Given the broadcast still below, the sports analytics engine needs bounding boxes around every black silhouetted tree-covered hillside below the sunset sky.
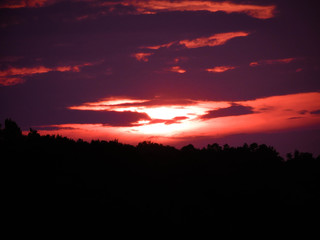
[0,119,320,235]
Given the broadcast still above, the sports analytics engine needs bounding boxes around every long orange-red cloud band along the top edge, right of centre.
[100,0,276,19]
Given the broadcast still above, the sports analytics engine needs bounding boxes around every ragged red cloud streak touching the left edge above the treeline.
[0,63,92,86]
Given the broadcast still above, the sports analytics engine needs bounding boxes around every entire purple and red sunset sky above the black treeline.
[0,0,320,155]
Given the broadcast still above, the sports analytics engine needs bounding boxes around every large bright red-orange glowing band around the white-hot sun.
[40,92,320,144]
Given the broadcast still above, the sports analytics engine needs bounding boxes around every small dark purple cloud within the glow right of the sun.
[201,104,255,119]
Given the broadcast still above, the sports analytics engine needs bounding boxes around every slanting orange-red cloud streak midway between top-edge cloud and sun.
[142,32,250,49]
